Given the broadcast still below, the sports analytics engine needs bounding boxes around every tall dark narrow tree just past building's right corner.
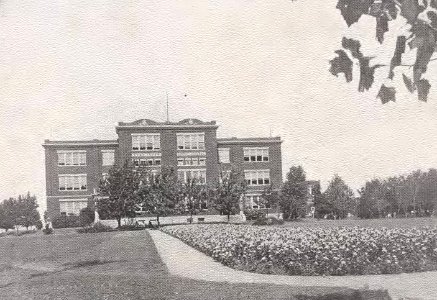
[279,166,307,220]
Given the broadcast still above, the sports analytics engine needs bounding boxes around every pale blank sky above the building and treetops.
[0,0,437,211]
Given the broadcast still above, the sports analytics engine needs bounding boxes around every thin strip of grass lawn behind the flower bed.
[279,217,437,228]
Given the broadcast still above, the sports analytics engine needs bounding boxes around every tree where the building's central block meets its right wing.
[213,169,246,222]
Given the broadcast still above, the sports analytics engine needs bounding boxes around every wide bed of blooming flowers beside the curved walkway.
[162,224,437,275]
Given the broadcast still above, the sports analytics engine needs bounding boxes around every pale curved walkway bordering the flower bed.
[149,230,437,300]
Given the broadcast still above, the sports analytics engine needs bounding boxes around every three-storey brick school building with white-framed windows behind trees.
[43,119,282,219]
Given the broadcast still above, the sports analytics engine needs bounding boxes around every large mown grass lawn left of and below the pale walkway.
[0,230,386,300]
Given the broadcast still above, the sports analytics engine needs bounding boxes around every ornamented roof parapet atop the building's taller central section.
[116,119,218,129]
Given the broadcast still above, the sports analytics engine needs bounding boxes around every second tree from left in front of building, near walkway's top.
[136,168,183,226]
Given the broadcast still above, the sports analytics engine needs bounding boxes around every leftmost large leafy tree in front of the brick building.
[97,162,147,227]
